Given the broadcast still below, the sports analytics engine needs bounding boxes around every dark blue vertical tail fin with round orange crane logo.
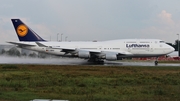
[11,19,45,41]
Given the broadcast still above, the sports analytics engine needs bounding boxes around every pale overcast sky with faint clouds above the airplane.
[0,0,180,44]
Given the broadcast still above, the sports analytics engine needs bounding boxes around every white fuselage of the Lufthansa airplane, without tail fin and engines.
[17,39,174,57]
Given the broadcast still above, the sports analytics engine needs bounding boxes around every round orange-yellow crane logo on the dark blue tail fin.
[17,24,28,37]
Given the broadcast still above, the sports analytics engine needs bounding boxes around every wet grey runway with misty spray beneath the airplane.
[0,56,180,66]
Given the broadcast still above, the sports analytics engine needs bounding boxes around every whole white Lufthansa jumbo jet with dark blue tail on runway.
[8,19,174,65]
